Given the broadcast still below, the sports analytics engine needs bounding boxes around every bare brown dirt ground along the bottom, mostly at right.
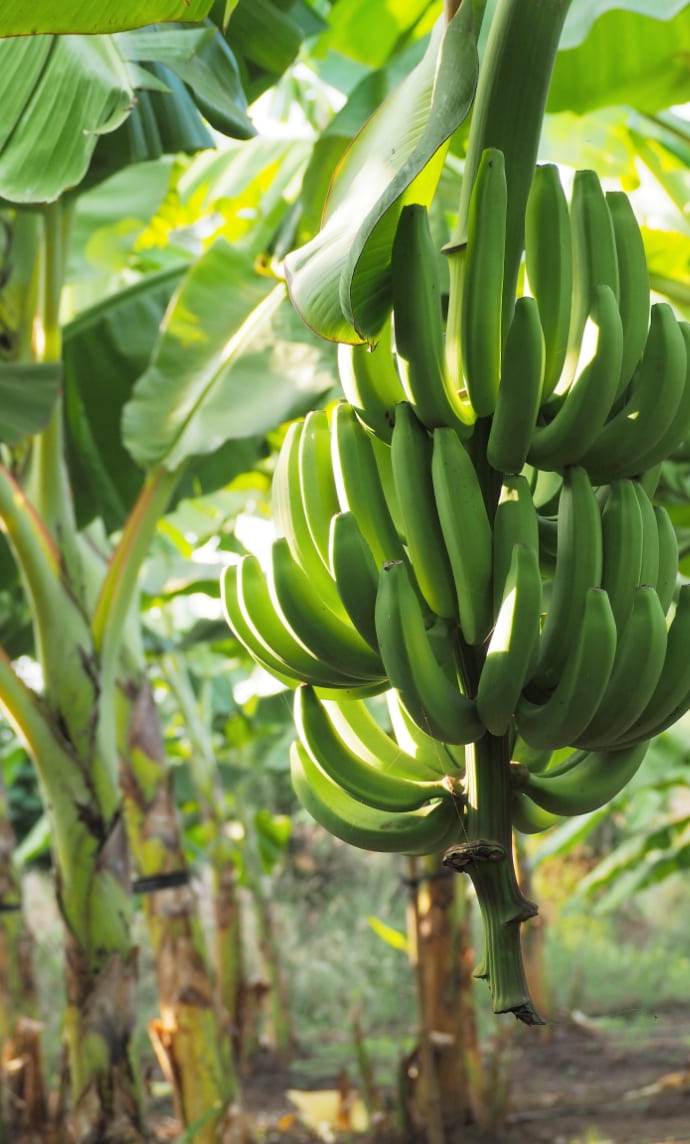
[230,1009,690,1144]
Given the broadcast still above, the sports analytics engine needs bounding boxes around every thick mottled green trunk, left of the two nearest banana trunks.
[0,636,144,1144]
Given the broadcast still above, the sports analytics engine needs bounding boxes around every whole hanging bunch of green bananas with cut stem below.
[222,143,690,1022]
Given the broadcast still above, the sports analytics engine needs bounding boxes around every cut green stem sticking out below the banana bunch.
[443,734,544,1025]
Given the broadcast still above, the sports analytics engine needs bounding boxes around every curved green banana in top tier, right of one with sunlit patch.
[580,302,688,484]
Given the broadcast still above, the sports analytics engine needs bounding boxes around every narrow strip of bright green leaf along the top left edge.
[0,0,213,35]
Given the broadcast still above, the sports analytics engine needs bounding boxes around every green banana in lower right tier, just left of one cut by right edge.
[573,585,666,749]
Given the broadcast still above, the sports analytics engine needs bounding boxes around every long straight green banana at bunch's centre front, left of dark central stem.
[431,429,493,645]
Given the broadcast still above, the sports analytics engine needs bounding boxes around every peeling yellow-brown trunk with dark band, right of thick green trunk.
[119,678,238,1144]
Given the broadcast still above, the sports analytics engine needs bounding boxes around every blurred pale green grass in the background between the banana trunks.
[16,827,690,1086]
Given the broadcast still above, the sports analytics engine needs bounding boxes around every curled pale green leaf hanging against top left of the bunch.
[285,3,477,342]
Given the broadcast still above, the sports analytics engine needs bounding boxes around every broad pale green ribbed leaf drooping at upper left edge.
[0,35,135,202]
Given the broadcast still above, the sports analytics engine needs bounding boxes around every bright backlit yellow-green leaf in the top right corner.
[547,0,690,114]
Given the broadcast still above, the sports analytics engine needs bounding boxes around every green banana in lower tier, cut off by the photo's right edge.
[613,583,690,745]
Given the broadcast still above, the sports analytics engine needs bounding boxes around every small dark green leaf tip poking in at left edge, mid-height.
[0,362,62,445]
